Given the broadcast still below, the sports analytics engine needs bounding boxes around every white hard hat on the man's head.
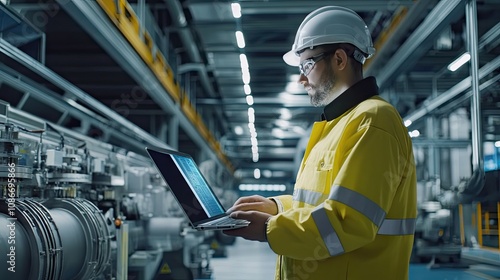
[283,6,375,66]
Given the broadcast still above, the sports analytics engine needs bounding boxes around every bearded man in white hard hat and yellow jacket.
[225,6,417,280]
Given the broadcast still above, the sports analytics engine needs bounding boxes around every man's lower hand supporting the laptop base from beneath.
[223,211,272,241]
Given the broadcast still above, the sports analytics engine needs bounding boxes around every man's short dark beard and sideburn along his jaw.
[309,64,337,107]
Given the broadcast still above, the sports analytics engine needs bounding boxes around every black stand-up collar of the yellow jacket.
[321,77,378,121]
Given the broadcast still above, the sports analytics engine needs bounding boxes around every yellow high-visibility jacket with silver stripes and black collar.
[266,77,417,280]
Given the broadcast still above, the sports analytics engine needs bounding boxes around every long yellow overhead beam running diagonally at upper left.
[97,0,234,172]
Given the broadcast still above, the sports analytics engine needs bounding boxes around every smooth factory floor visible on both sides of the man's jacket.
[211,238,500,280]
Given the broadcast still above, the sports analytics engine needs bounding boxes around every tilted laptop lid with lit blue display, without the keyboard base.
[147,149,225,223]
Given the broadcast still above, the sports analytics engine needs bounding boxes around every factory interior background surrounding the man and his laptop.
[0,0,500,280]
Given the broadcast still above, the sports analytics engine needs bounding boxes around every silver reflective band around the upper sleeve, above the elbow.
[328,186,386,227]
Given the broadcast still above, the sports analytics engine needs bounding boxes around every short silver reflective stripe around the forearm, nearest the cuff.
[311,203,344,256]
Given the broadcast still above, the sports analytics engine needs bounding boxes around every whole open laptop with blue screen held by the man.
[146,147,250,230]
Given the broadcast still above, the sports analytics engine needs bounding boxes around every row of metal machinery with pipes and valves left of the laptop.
[0,103,225,280]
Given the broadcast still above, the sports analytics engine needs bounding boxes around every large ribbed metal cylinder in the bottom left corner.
[0,198,111,280]
